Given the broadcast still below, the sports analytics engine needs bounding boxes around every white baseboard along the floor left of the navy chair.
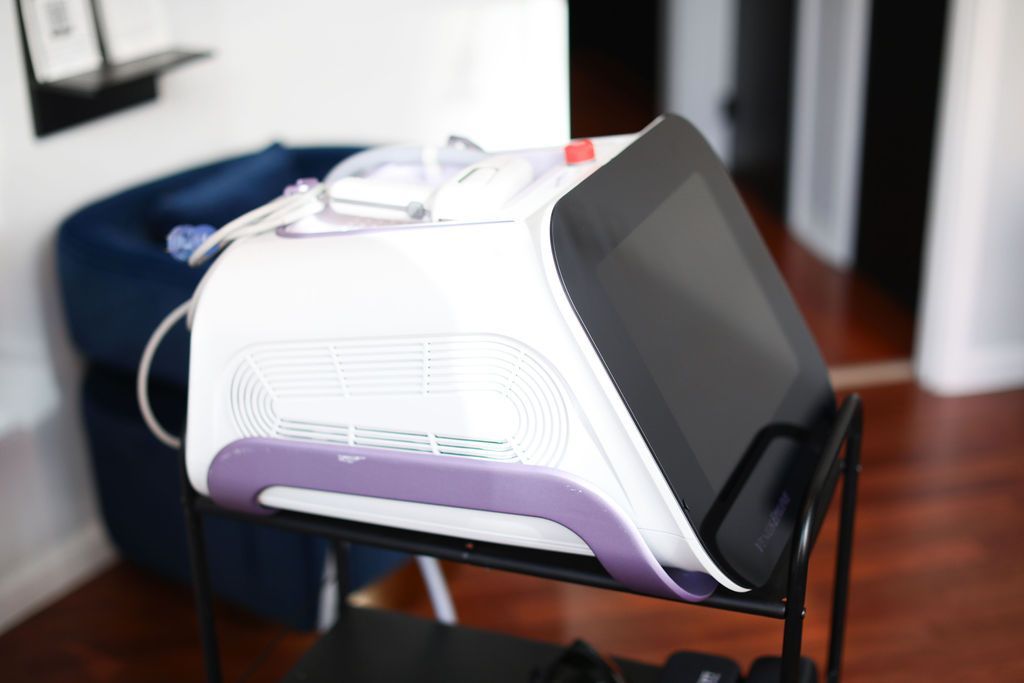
[0,519,117,633]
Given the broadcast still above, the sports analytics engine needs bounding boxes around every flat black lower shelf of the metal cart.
[284,607,658,683]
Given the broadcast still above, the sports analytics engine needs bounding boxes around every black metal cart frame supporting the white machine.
[181,394,863,683]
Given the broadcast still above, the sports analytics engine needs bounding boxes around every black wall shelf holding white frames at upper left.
[14,0,212,137]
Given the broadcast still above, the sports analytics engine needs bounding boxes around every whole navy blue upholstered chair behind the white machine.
[57,145,406,628]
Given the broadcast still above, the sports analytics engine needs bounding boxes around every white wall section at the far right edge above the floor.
[915,0,1024,394]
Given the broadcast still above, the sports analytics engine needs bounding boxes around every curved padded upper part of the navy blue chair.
[57,143,358,386]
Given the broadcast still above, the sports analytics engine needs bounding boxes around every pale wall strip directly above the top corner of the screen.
[662,0,739,166]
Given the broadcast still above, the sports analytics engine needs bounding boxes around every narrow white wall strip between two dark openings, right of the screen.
[786,0,871,268]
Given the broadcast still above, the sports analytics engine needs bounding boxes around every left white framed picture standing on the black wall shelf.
[20,0,103,83]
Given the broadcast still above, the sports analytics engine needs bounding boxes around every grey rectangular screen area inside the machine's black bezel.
[597,175,797,490]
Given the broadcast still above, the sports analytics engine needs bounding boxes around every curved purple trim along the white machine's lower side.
[208,438,716,602]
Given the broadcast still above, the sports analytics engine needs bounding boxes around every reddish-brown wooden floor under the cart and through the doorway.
[0,194,1024,682]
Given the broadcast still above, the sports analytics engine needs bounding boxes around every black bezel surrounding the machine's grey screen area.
[551,115,835,585]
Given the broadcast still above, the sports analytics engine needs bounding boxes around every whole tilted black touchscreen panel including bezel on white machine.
[551,116,835,585]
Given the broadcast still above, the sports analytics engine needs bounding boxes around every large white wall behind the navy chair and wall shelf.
[0,0,568,630]
